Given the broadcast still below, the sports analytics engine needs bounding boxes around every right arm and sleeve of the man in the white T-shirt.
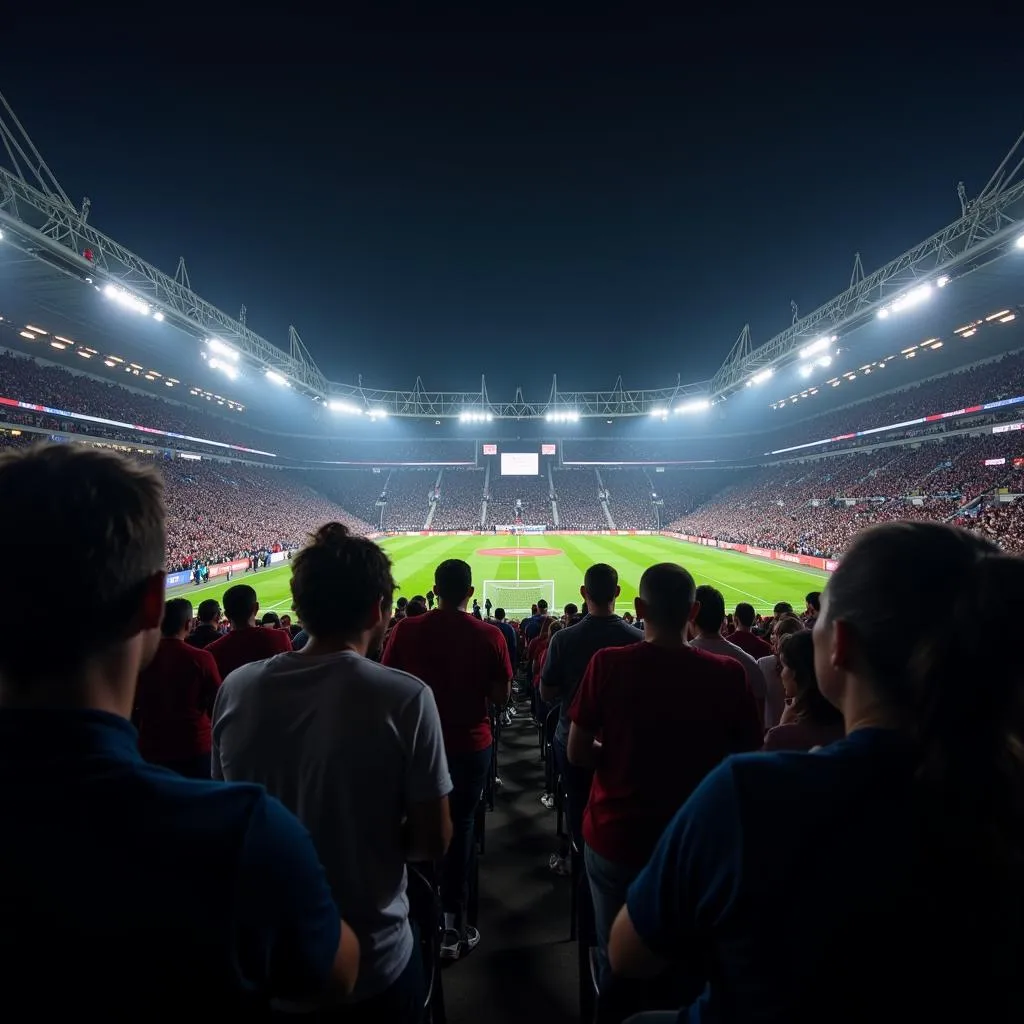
[399,684,452,862]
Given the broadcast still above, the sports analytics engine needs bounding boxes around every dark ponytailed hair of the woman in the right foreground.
[824,522,1024,868]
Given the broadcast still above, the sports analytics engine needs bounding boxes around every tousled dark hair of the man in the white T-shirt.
[292,522,395,637]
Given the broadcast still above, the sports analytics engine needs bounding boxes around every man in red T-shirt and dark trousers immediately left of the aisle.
[382,558,512,959]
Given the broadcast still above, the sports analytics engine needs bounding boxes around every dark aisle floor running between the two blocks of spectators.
[443,716,578,1024]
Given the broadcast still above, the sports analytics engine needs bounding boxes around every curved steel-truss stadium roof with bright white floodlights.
[0,89,1024,423]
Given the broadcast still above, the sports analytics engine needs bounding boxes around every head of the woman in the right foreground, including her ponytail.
[814,522,1024,831]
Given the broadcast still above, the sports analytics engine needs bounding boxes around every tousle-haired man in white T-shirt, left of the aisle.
[214,523,452,1024]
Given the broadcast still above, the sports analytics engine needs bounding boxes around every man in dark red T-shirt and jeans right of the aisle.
[568,562,763,977]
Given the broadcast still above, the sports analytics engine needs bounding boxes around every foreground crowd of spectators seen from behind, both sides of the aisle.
[0,444,1024,1024]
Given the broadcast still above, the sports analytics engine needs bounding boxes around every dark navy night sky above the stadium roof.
[0,17,1024,396]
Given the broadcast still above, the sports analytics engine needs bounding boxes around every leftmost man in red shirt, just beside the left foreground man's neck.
[133,597,220,778]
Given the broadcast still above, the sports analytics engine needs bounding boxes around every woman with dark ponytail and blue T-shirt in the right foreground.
[609,522,1024,1024]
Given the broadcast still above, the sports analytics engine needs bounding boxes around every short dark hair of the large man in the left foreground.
[0,443,166,683]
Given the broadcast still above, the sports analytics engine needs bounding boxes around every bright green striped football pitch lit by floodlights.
[167,534,827,614]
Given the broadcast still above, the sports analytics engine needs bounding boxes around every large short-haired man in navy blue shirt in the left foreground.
[0,444,358,1021]
